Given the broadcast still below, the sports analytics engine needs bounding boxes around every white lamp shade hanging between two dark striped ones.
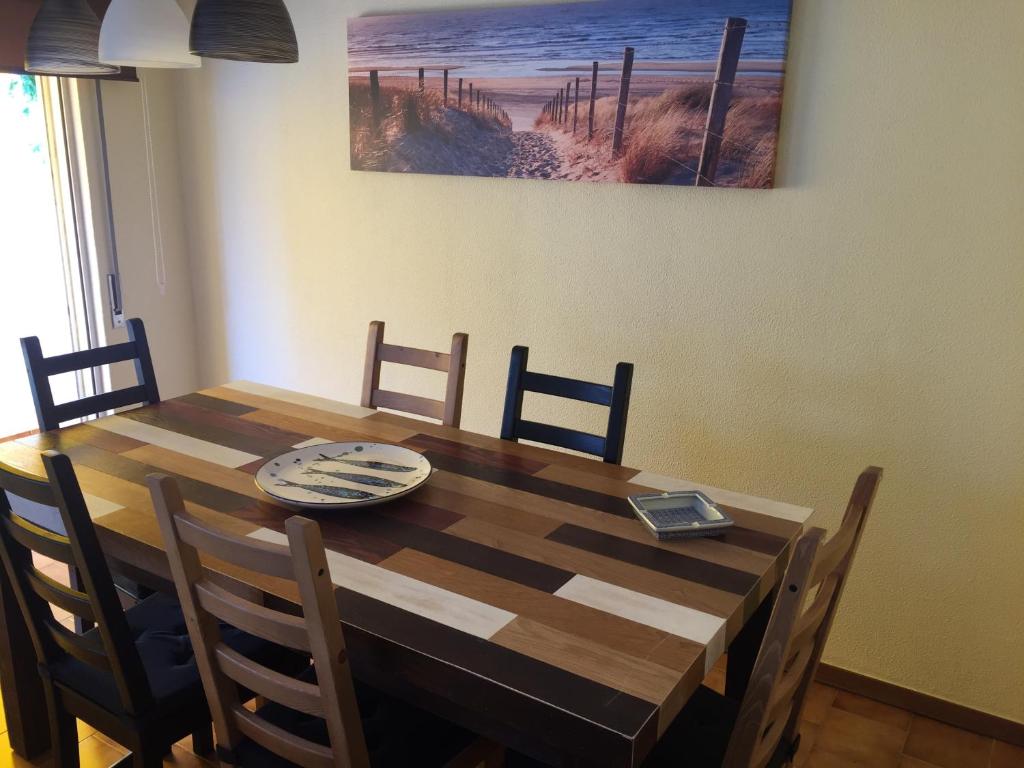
[99,0,203,69]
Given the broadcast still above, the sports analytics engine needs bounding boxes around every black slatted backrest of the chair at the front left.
[0,451,153,715]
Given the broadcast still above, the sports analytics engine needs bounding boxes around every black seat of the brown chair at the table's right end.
[507,685,790,768]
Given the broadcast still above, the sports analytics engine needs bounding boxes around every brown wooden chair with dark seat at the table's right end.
[645,467,882,768]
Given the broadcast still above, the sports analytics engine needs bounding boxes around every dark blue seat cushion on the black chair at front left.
[50,594,301,717]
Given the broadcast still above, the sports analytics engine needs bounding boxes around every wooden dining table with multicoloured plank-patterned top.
[0,382,811,768]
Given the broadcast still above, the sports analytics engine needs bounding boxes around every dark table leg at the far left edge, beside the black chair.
[0,568,50,760]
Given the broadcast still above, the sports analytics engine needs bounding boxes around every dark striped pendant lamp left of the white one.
[25,0,121,75]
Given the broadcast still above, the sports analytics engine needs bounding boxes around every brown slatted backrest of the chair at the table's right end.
[724,467,882,768]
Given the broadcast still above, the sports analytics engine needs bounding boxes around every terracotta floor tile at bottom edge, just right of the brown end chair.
[809,707,906,768]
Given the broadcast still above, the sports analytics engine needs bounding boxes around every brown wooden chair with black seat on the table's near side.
[148,475,500,768]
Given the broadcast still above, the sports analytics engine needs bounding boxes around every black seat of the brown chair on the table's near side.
[234,668,476,768]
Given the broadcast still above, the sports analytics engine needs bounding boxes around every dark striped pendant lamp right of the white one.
[189,0,299,63]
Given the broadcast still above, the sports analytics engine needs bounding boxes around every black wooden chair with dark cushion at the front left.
[0,452,225,768]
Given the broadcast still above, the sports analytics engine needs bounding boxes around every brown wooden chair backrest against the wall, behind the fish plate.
[361,321,469,427]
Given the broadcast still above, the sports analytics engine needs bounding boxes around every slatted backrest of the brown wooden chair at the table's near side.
[148,475,369,768]
